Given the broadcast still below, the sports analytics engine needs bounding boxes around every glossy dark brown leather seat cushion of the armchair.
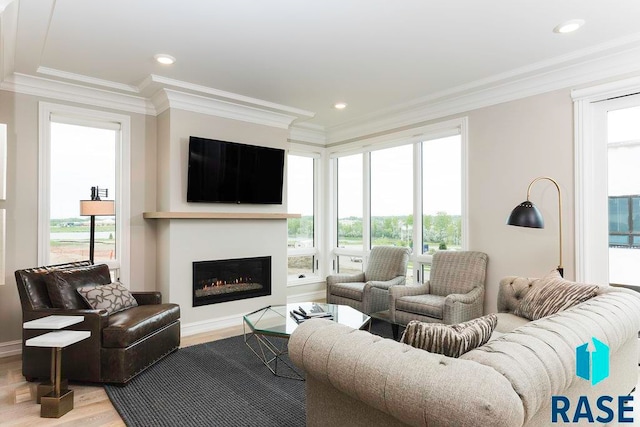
[102,304,180,348]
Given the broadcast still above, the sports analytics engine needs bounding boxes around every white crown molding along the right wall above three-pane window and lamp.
[327,34,640,145]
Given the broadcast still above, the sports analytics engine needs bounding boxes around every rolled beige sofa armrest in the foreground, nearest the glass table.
[289,319,524,427]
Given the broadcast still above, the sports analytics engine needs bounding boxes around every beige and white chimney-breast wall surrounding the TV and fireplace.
[156,109,289,333]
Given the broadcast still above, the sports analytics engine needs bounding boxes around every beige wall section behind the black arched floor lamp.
[467,90,575,312]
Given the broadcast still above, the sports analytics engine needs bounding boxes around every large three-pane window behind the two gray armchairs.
[332,119,466,284]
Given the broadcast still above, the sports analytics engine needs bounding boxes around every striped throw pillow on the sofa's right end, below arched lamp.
[513,270,598,320]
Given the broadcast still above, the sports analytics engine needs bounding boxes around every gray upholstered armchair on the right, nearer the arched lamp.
[389,251,489,325]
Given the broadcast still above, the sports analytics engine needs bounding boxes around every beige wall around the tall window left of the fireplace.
[0,90,156,344]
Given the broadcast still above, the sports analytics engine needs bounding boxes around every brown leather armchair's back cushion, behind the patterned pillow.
[45,264,111,310]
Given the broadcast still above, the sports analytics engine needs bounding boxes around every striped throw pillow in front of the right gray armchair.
[400,314,498,357]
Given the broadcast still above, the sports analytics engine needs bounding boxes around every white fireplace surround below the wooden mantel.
[157,219,287,336]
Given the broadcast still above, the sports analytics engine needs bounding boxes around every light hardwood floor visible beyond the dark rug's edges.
[0,326,242,427]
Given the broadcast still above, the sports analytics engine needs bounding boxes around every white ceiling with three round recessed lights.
[0,0,640,129]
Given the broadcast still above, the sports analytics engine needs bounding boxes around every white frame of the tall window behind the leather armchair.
[38,102,131,286]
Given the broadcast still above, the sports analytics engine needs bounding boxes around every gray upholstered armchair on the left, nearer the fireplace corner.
[327,246,409,314]
